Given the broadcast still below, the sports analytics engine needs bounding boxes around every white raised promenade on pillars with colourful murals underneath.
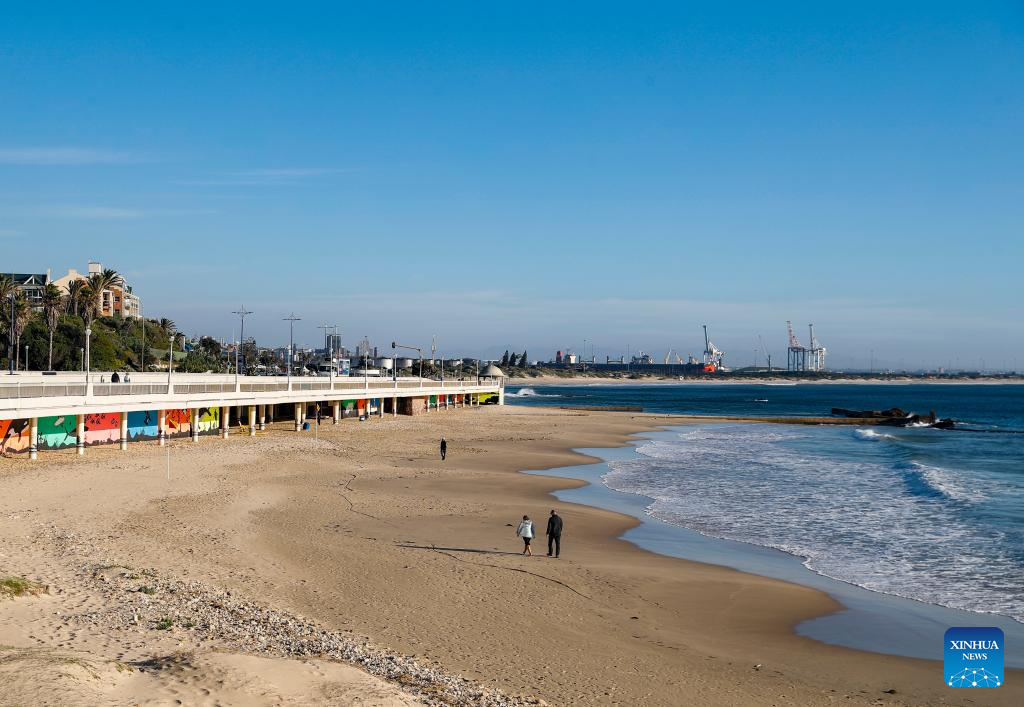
[0,372,504,459]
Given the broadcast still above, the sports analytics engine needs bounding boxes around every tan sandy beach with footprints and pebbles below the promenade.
[0,405,1024,706]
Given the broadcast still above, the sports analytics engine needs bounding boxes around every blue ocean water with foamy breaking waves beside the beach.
[507,384,1024,622]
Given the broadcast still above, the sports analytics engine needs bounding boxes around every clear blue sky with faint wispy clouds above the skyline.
[0,2,1024,368]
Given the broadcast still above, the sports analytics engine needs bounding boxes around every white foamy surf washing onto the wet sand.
[604,424,1024,621]
